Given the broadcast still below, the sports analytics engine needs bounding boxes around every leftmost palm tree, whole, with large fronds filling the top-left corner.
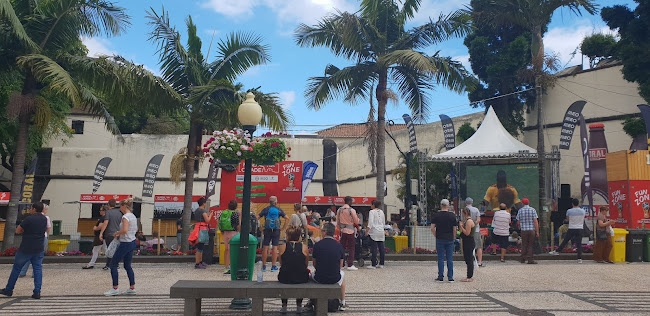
[0,0,173,248]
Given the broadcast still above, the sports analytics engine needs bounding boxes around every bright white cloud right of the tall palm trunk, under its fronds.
[544,21,614,67]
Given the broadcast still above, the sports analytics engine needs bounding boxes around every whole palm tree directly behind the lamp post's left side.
[147,9,292,251]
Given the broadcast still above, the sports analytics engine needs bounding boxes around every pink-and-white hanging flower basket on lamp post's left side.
[203,129,253,165]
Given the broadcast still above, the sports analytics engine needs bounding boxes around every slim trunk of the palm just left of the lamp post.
[181,120,201,252]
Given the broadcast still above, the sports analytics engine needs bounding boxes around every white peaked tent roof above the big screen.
[429,107,537,161]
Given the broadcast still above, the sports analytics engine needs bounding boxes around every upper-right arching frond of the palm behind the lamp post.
[209,33,271,81]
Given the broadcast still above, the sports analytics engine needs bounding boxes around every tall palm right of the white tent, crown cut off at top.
[478,0,598,243]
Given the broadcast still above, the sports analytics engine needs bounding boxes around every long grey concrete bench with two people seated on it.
[169,280,341,316]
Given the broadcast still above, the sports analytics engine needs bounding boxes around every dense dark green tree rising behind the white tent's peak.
[464,0,534,136]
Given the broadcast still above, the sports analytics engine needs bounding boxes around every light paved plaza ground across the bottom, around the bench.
[0,260,650,316]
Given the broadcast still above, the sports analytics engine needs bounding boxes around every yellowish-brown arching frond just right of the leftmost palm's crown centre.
[16,54,80,105]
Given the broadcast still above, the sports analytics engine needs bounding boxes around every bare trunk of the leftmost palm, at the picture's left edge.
[2,113,29,250]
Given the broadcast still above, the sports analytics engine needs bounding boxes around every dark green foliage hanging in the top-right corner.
[601,0,650,103]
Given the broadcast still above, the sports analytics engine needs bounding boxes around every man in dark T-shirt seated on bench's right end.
[311,223,347,311]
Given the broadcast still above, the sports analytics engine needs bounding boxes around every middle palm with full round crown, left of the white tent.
[295,0,473,206]
